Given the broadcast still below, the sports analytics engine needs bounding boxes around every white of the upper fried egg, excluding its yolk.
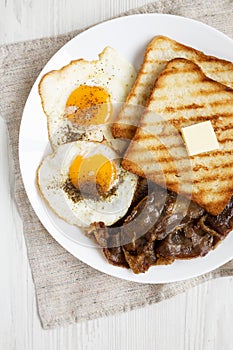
[39,47,136,149]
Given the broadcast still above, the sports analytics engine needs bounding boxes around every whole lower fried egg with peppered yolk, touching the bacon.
[37,141,138,227]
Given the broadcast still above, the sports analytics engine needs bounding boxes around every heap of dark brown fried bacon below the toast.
[89,186,233,273]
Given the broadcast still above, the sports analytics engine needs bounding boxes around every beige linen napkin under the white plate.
[0,0,233,328]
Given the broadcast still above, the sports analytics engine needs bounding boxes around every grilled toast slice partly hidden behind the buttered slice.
[112,36,233,139]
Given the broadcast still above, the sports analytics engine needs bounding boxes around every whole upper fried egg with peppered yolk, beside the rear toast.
[39,47,136,149]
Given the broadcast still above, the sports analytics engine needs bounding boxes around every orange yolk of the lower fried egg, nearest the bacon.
[69,154,117,195]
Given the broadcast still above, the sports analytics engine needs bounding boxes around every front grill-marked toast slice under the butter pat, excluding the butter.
[122,58,233,215]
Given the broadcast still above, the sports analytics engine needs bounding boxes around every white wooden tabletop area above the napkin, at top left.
[0,0,150,44]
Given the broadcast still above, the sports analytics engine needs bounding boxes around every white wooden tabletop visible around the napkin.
[0,0,233,350]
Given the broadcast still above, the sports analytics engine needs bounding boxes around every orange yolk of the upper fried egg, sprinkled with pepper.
[66,85,112,126]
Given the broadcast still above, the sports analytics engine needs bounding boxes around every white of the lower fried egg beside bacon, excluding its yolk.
[37,141,138,227]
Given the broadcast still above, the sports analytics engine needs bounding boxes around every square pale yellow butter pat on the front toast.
[181,120,219,156]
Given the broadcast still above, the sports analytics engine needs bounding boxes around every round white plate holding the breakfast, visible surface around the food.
[19,14,233,283]
